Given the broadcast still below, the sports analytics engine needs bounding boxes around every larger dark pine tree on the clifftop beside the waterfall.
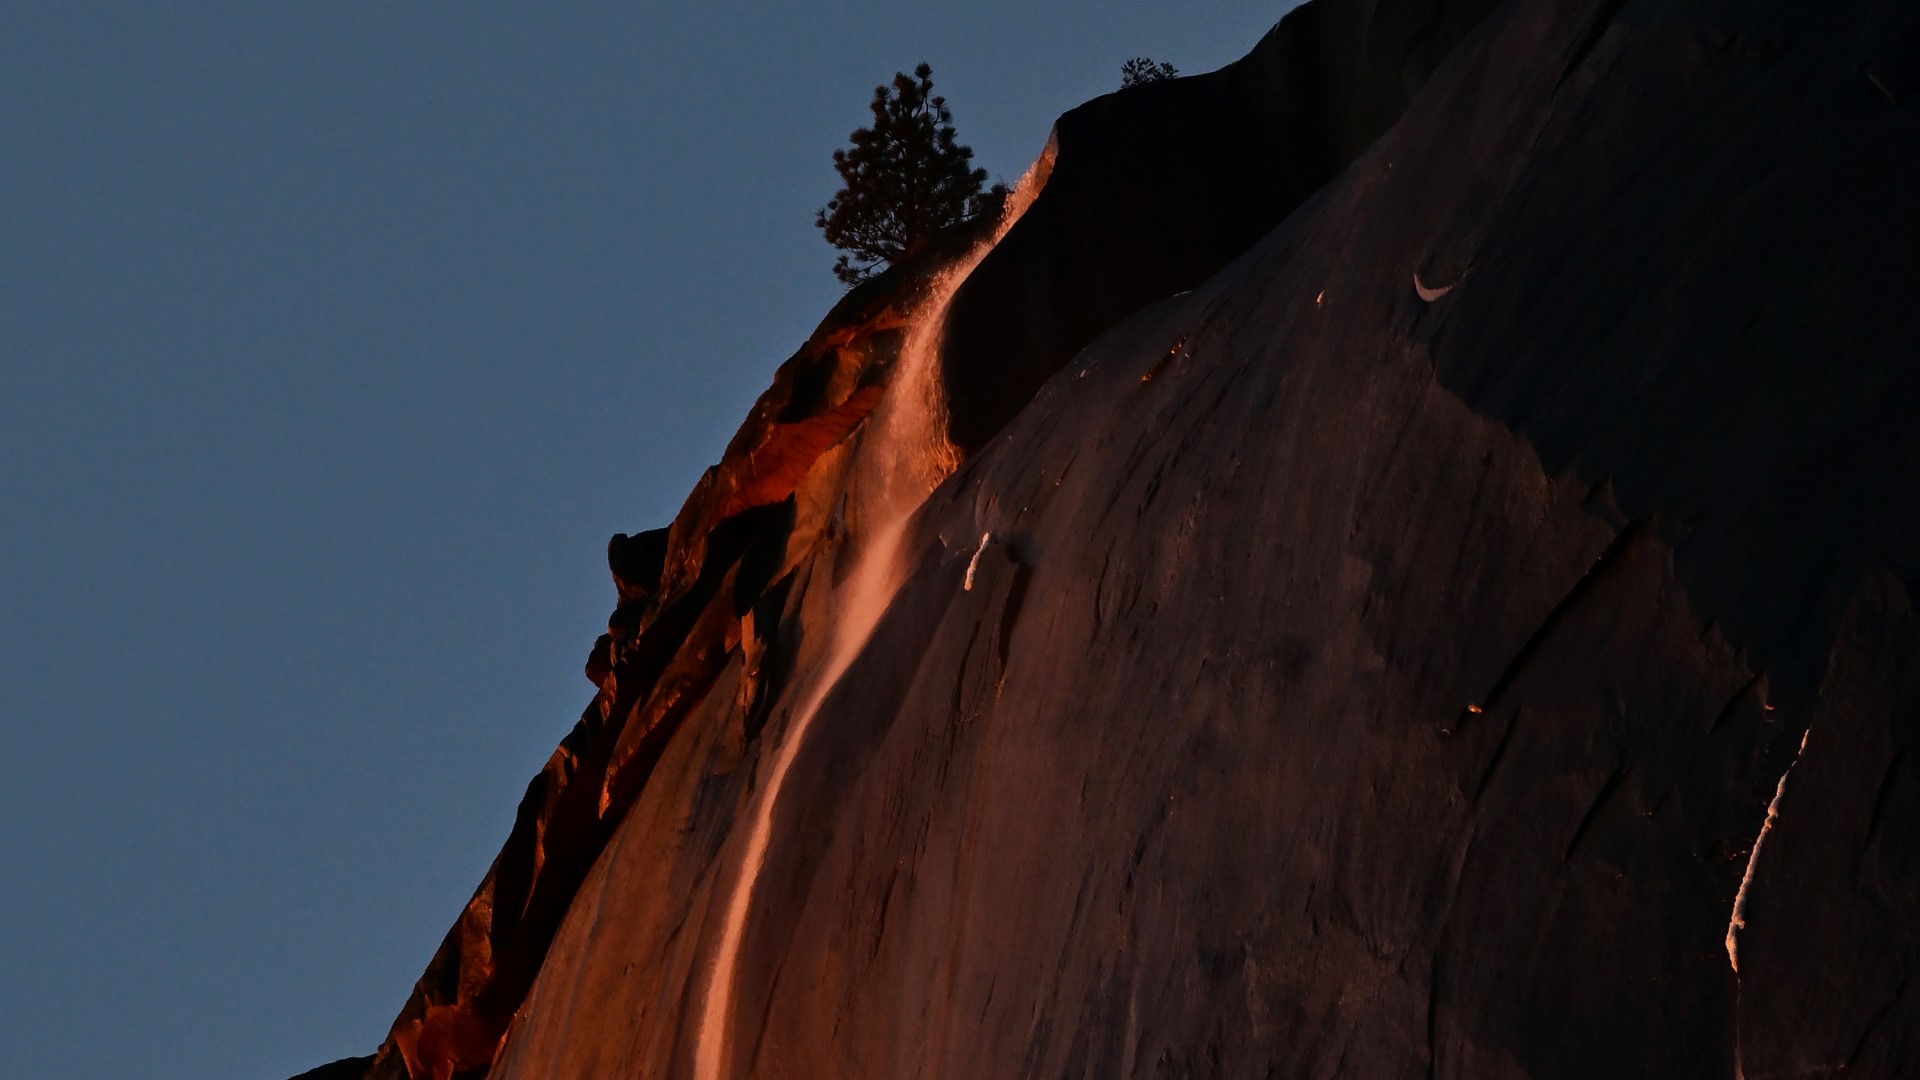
[814,63,1006,284]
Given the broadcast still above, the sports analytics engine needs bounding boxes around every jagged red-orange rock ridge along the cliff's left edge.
[341,178,985,1080]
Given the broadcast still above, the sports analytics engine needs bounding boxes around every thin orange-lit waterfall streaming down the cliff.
[693,142,1054,1080]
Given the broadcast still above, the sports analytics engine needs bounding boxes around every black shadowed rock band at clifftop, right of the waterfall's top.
[945,0,1494,454]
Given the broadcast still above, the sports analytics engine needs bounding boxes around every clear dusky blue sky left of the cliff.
[0,0,1290,1080]
